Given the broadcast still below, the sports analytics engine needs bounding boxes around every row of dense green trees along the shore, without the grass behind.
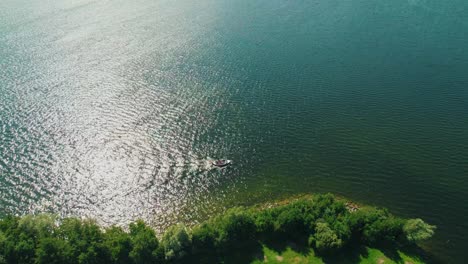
[0,194,435,264]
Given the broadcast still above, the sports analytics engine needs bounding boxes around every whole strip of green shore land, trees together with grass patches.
[0,194,437,264]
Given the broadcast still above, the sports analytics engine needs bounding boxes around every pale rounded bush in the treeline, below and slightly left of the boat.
[161,225,192,260]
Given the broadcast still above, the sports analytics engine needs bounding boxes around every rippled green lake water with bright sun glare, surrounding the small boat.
[0,0,468,263]
